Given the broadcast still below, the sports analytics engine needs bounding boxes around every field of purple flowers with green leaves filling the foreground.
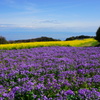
[0,47,100,100]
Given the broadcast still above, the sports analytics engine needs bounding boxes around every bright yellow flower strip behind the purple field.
[0,38,98,50]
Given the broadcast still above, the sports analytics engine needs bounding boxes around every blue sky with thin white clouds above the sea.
[0,0,100,36]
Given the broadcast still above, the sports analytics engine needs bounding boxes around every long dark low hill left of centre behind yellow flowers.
[9,37,61,43]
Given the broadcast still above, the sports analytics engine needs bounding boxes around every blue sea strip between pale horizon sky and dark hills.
[0,31,96,41]
